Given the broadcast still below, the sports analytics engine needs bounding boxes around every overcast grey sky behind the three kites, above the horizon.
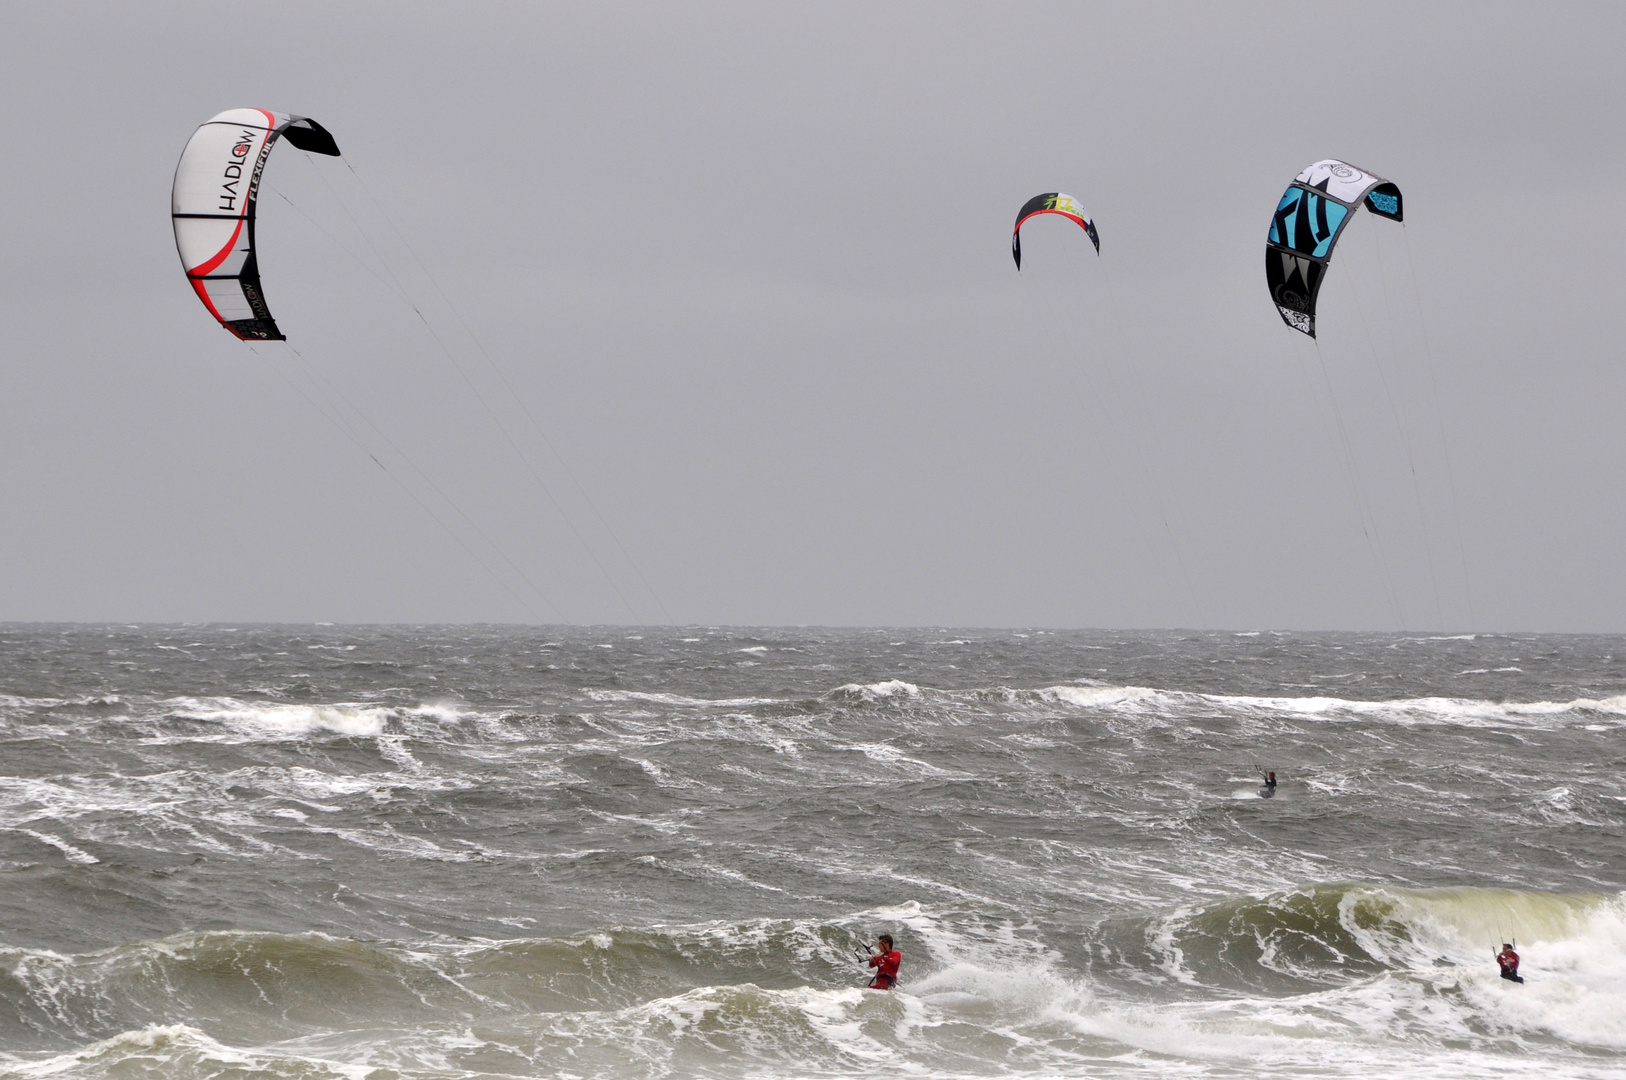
[0,2,1626,631]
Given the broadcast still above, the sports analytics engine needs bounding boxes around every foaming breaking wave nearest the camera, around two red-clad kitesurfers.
[0,885,1626,1077]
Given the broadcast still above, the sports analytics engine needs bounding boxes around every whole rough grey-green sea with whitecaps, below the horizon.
[0,625,1626,1080]
